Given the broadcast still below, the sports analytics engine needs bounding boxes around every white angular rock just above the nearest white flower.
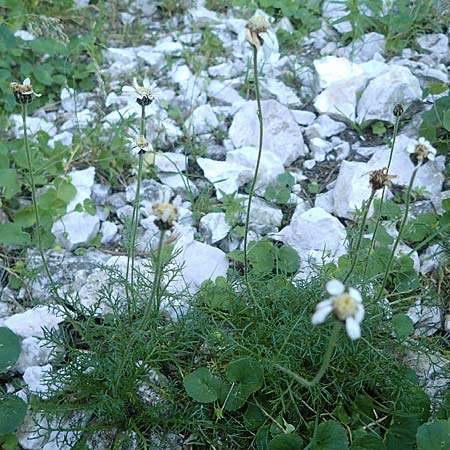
[275,207,346,261]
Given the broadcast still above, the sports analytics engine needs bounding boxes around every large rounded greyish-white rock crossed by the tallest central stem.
[229,100,306,165]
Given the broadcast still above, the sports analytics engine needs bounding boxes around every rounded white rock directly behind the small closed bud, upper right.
[356,66,422,124]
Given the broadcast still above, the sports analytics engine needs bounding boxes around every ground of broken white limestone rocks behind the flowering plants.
[0,1,450,450]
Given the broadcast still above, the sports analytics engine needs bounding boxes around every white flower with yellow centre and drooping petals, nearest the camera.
[312,280,364,339]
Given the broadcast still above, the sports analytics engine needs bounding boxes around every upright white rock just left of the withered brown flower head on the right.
[333,161,373,219]
